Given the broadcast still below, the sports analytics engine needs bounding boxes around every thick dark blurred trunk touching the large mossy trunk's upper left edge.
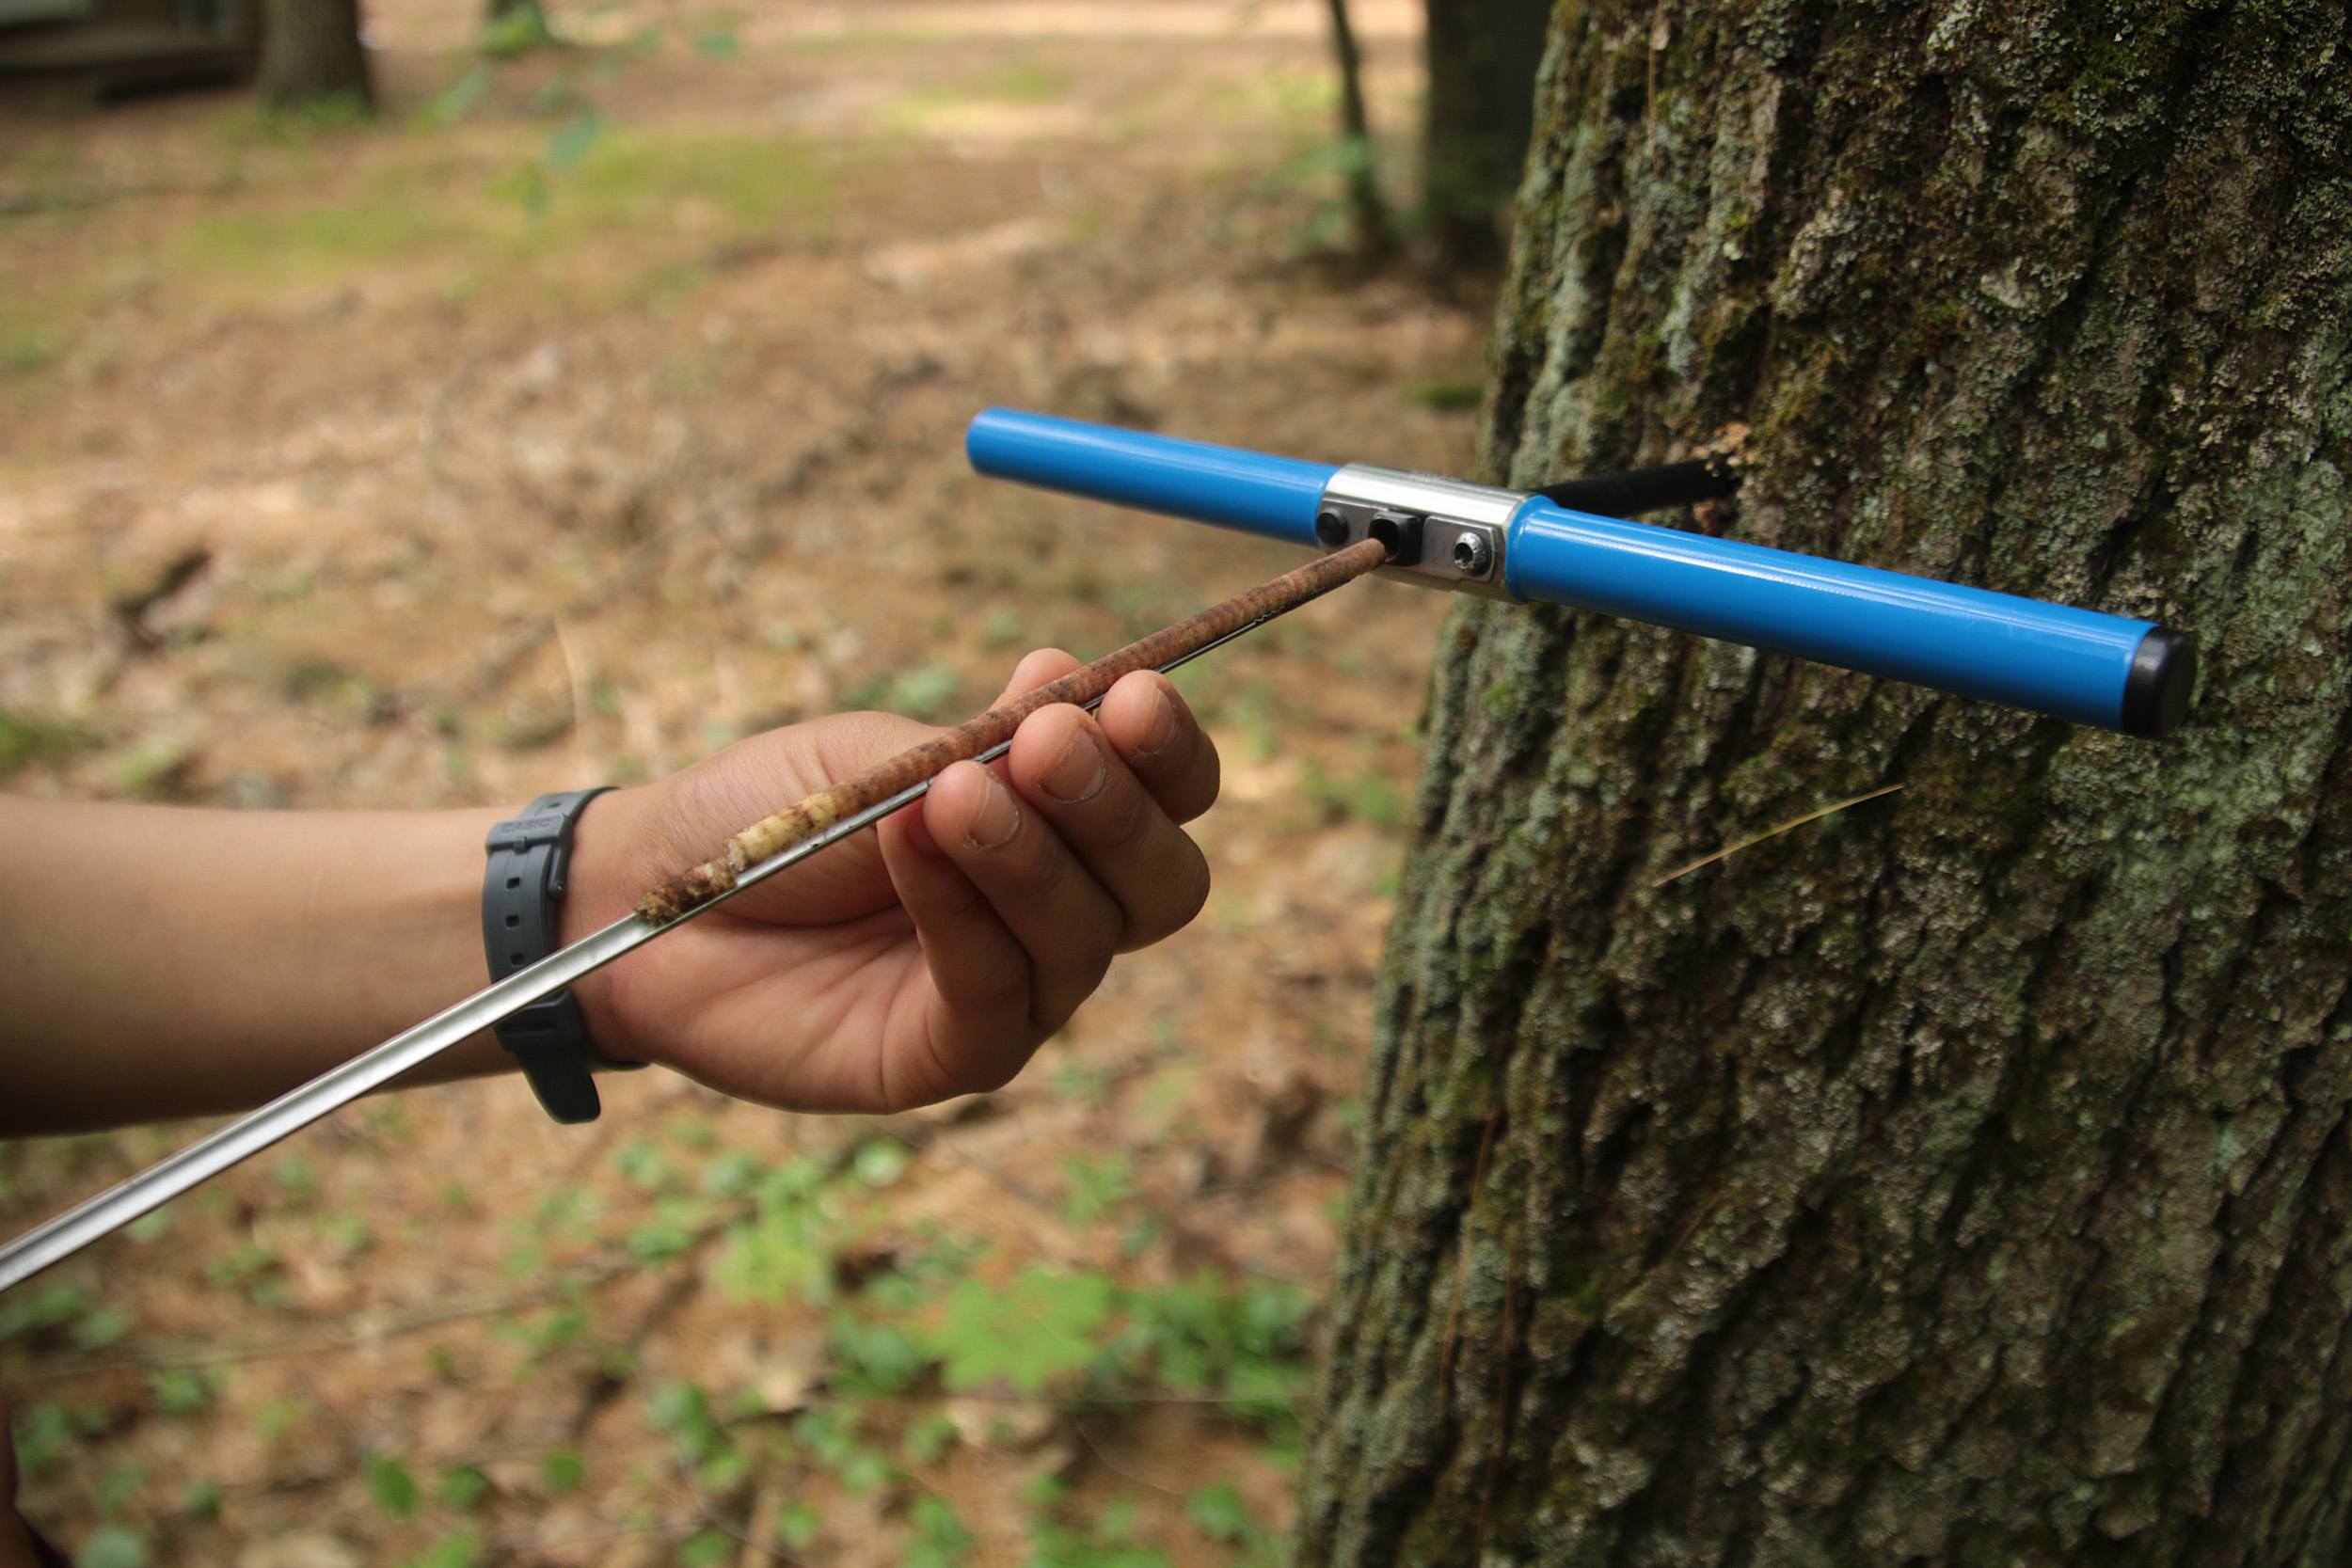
[1421,0,1552,268]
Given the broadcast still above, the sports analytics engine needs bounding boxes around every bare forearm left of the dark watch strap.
[0,797,511,1133]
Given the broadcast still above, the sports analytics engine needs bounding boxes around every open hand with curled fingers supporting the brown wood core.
[563,649,1218,1112]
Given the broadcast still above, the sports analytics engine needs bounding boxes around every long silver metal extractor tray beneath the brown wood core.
[0,611,1279,1291]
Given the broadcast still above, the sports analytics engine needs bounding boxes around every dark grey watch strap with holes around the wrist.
[483,785,644,1121]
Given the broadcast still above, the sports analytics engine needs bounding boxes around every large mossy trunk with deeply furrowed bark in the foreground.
[1298,0,2352,1568]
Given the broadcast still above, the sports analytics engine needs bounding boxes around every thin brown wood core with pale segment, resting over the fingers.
[638,538,1388,927]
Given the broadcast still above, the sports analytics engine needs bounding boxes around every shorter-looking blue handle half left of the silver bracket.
[964,409,1339,547]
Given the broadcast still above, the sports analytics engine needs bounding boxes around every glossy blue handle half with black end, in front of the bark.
[1503,499,2154,734]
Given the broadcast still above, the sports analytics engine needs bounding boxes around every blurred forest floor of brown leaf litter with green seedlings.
[0,0,1485,1568]
